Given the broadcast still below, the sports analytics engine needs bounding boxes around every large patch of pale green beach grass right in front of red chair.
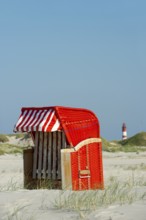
[54,175,146,216]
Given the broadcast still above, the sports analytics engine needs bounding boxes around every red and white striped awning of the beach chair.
[14,108,61,132]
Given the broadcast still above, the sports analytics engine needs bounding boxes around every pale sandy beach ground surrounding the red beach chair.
[0,152,146,220]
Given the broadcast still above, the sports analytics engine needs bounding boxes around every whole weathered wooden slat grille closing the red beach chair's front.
[33,131,67,180]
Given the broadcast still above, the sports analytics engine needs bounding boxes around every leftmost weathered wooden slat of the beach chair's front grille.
[33,132,39,179]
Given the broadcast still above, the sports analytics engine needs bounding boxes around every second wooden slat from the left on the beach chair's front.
[38,132,43,179]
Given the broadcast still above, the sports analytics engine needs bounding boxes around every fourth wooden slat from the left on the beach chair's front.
[48,132,52,179]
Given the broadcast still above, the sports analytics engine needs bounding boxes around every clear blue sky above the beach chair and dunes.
[0,0,146,140]
